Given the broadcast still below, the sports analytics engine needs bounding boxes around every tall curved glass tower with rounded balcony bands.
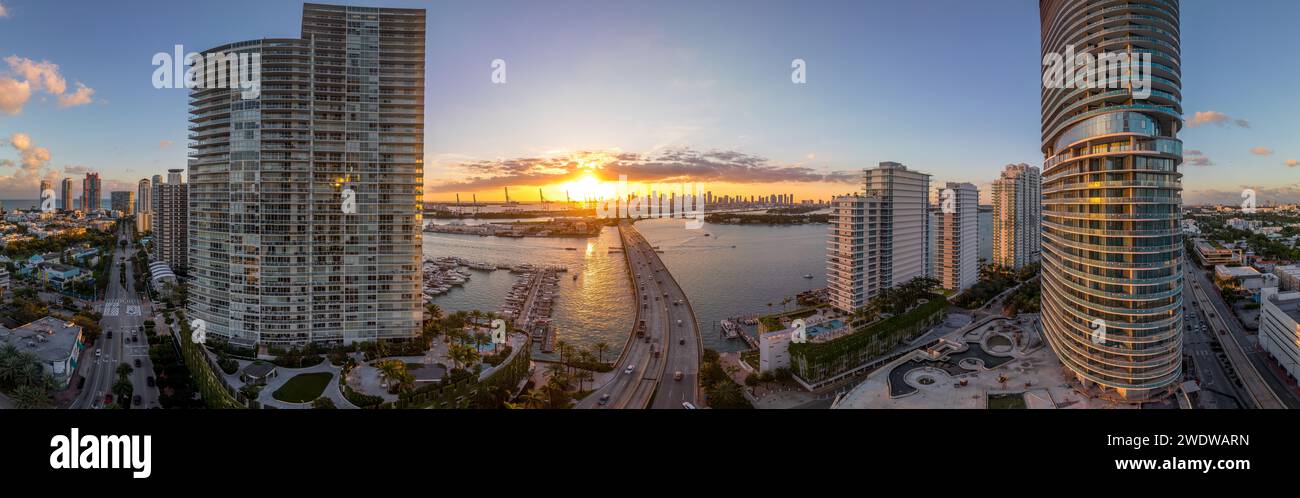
[1039,0,1183,402]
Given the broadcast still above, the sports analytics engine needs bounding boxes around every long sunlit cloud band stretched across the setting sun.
[426,148,861,194]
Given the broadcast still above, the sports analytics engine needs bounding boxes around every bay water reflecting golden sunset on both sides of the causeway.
[424,220,827,360]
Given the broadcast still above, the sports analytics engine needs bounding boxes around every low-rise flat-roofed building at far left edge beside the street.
[0,316,86,387]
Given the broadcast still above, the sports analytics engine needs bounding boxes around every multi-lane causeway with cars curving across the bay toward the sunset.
[577,222,702,408]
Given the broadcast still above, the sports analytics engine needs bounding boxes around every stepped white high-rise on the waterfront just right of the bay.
[827,163,930,311]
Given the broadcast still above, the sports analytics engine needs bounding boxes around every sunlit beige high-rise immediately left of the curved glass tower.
[991,164,1043,269]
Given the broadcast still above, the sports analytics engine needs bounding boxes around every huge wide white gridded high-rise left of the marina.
[188,4,425,346]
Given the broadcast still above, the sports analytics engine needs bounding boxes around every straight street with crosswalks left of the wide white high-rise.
[70,224,159,408]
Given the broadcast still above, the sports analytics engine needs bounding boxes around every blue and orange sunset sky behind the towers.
[0,0,1300,204]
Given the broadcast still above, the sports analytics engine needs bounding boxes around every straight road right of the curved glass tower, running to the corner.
[1183,256,1300,408]
